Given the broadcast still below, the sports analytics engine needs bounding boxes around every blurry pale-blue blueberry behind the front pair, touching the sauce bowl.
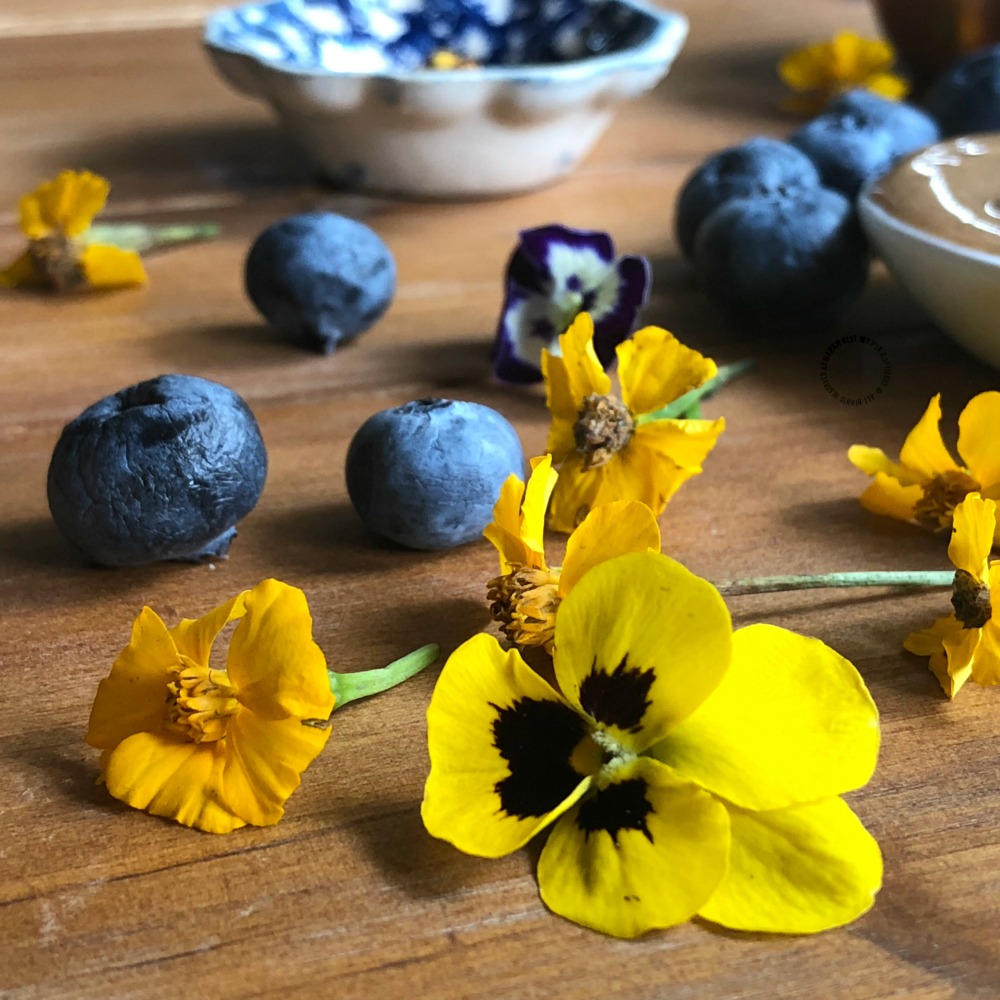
[788,90,939,198]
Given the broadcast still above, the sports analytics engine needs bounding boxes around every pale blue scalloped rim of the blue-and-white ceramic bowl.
[202,0,689,86]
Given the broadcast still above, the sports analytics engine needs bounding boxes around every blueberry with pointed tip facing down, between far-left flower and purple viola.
[245,212,396,354]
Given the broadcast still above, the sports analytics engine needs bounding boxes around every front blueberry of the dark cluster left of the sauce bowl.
[695,187,868,332]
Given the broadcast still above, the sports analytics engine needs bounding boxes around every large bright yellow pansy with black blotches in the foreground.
[422,553,882,937]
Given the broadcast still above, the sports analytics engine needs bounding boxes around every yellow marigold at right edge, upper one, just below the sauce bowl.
[847,392,1000,542]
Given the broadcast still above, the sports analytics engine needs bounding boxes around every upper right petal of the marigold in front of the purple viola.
[615,326,718,415]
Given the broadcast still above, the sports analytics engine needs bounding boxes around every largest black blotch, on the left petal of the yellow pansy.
[493,698,587,816]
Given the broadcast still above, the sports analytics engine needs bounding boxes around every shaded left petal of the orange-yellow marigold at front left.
[87,608,181,752]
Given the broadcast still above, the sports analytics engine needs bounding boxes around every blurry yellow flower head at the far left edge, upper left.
[0,170,146,292]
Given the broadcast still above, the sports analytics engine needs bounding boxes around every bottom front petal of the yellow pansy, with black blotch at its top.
[538,758,729,938]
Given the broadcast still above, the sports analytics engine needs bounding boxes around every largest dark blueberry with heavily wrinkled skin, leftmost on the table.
[48,375,267,566]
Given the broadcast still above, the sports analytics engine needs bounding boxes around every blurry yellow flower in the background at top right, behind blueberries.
[778,31,910,115]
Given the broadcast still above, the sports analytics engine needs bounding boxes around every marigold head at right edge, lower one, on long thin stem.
[903,493,1000,698]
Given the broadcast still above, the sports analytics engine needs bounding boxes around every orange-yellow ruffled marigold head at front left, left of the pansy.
[87,580,334,833]
